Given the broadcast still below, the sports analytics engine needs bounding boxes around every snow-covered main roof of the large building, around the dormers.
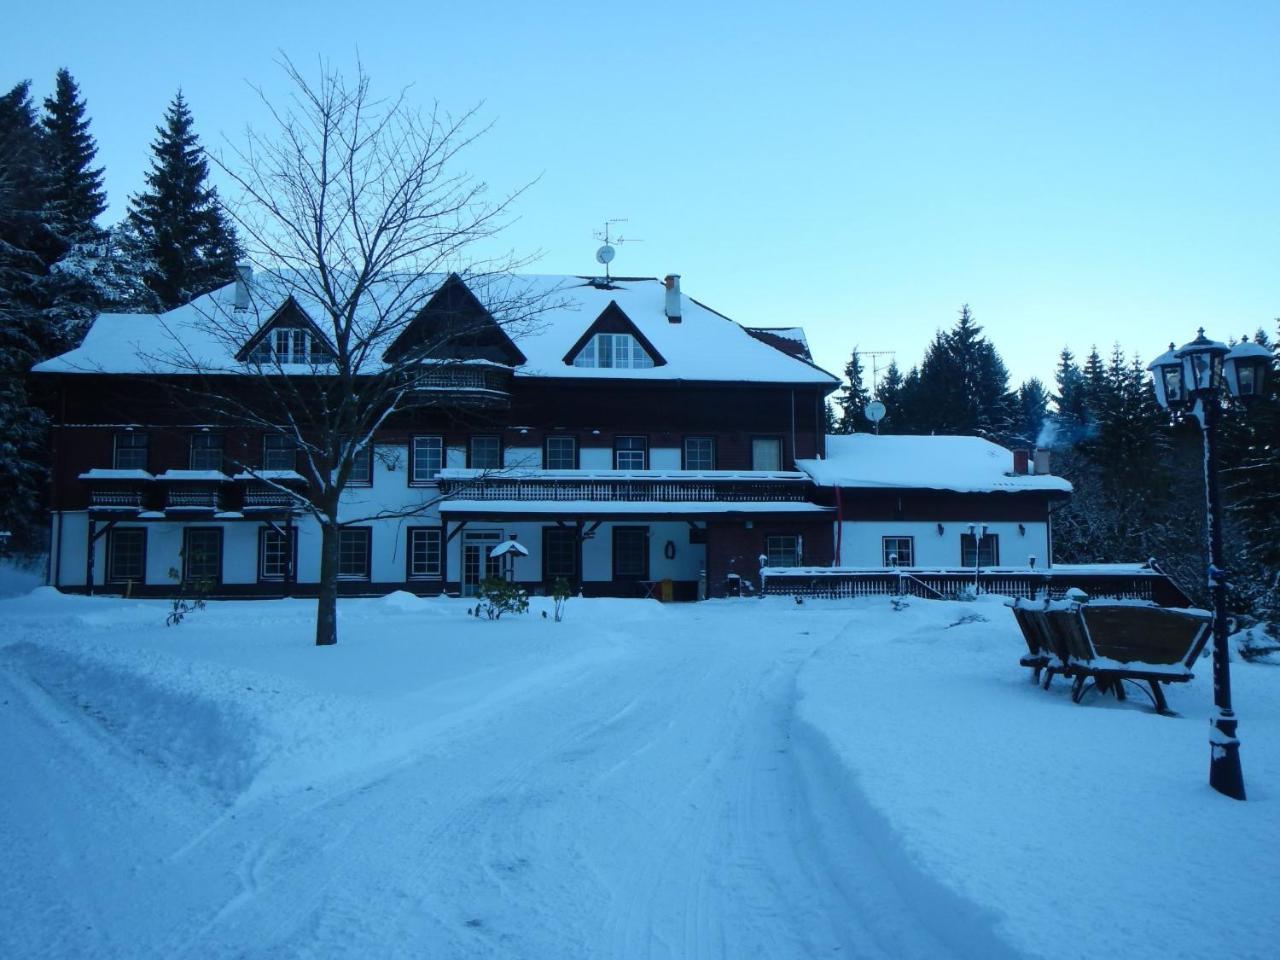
[36,274,838,387]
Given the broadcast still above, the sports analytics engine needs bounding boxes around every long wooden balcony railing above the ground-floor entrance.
[440,476,808,503]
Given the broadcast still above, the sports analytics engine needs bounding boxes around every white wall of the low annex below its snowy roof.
[840,518,1048,567]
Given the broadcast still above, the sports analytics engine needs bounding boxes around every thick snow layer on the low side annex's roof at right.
[796,434,1071,493]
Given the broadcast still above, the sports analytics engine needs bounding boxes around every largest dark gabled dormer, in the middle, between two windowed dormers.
[384,274,525,366]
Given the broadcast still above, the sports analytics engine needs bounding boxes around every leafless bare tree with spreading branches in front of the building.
[154,59,547,645]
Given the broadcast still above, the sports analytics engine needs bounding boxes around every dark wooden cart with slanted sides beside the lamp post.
[1012,594,1212,713]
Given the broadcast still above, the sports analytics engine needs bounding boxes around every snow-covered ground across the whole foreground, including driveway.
[0,589,1280,960]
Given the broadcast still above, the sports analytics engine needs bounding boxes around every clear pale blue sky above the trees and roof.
[0,0,1280,383]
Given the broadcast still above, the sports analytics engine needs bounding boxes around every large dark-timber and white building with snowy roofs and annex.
[36,275,1069,599]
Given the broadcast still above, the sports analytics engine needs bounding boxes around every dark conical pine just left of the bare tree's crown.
[129,91,239,310]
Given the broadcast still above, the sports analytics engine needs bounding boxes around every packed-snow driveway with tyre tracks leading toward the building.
[0,605,1009,959]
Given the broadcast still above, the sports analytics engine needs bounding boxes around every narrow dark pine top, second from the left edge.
[44,68,106,247]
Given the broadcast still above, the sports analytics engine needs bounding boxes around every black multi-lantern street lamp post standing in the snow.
[1147,328,1271,800]
